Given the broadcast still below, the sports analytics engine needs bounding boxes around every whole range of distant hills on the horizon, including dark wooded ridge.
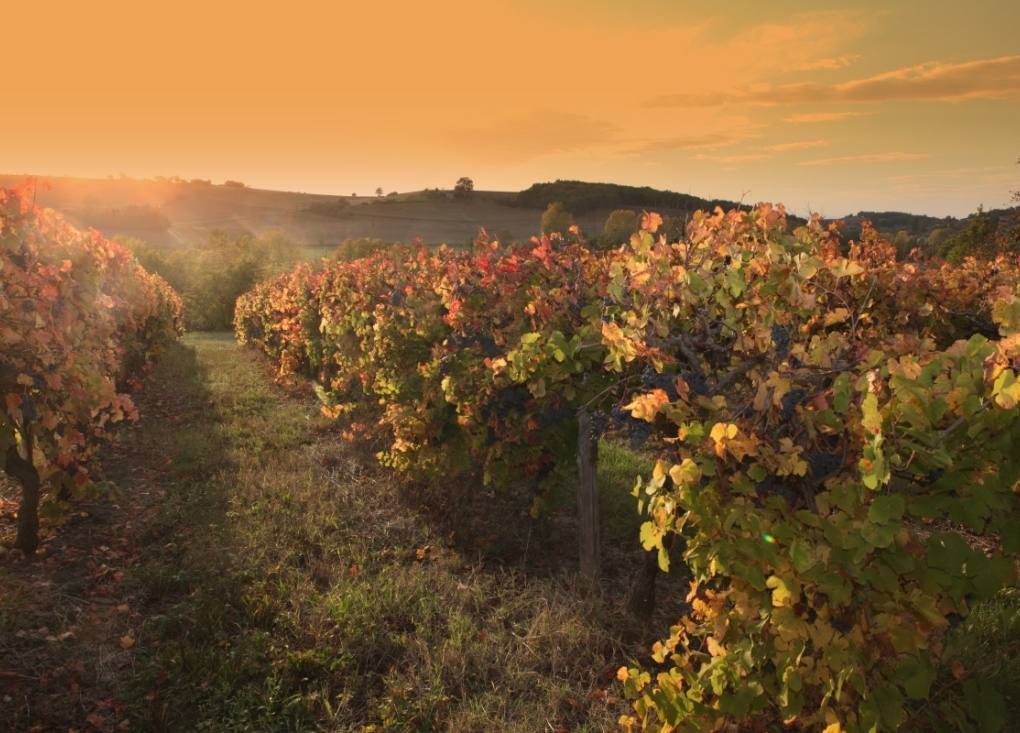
[0,174,995,256]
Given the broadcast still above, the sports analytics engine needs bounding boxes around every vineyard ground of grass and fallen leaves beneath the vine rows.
[0,334,1020,733]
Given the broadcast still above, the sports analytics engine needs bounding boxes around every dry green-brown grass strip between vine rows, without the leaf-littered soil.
[111,335,656,733]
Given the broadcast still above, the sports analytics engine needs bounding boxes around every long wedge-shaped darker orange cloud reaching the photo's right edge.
[643,56,1020,108]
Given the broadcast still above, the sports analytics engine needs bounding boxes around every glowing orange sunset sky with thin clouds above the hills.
[0,0,1020,217]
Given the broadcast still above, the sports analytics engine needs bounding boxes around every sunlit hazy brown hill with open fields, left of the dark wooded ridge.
[0,175,554,249]
